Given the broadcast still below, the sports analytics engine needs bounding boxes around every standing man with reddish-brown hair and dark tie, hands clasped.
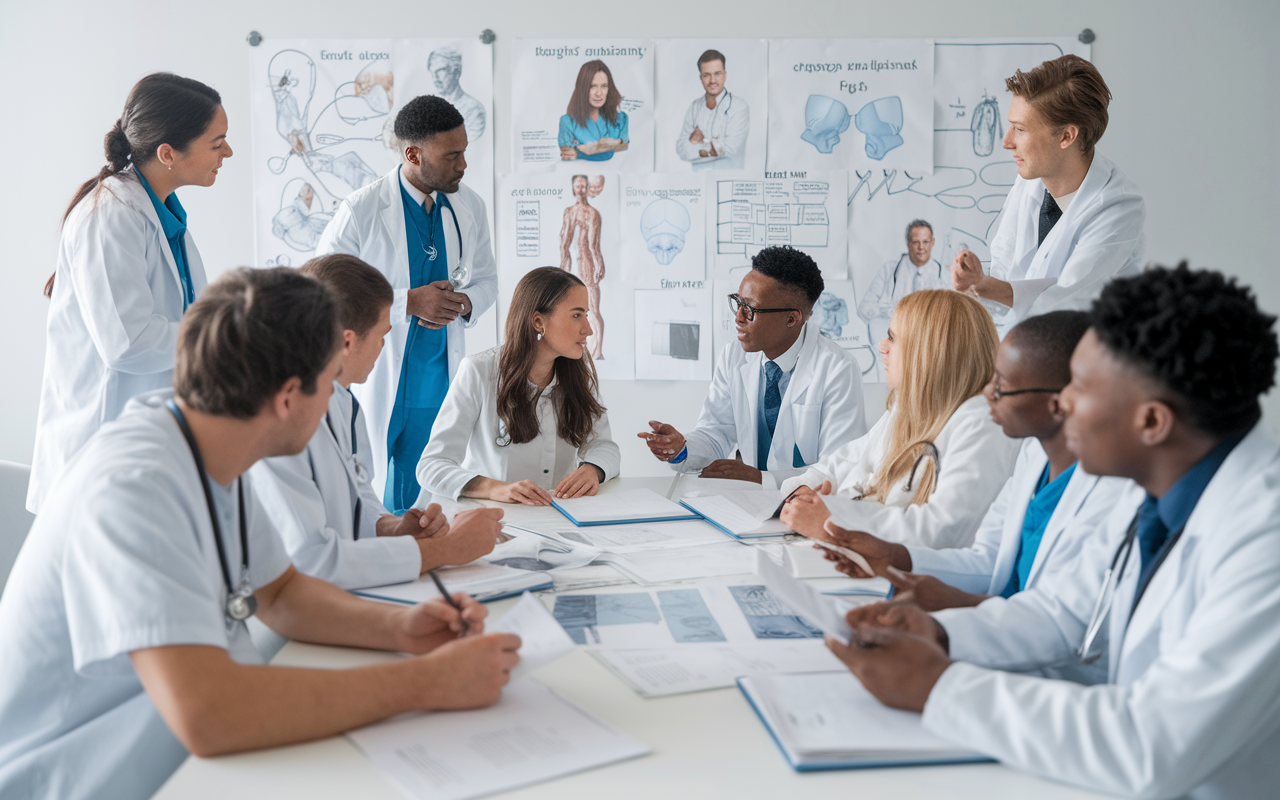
[951,55,1147,335]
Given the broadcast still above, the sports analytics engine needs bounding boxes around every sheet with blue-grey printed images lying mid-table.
[552,585,822,649]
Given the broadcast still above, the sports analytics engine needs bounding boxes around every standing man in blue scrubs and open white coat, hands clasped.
[316,96,498,515]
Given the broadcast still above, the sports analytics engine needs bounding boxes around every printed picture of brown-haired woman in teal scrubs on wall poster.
[558,59,631,161]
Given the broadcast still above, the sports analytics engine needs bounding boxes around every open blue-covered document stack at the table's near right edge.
[737,671,991,772]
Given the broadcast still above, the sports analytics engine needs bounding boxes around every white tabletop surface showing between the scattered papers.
[156,477,1101,800]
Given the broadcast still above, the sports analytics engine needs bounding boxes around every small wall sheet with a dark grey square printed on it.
[635,289,713,380]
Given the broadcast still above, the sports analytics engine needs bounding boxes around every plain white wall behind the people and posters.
[0,0,1280,475]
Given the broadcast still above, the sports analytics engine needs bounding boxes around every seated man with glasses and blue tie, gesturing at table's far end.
[636,246,867,489]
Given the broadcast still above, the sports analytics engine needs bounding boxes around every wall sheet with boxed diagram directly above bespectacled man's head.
[716,170,849,279]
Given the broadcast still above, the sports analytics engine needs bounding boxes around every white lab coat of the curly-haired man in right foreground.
[924,424,1280,800]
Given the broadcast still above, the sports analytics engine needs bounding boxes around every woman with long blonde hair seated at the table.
[782,289,1020,548]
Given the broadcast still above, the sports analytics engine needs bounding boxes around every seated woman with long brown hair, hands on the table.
[417,266,621,506]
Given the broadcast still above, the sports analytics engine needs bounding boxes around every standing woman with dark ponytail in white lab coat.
[27,73,232,513]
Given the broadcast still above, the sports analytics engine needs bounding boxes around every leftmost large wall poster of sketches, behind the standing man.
[251,40,493,266]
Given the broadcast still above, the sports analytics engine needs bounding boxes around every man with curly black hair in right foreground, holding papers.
[828,264,1280,799]
